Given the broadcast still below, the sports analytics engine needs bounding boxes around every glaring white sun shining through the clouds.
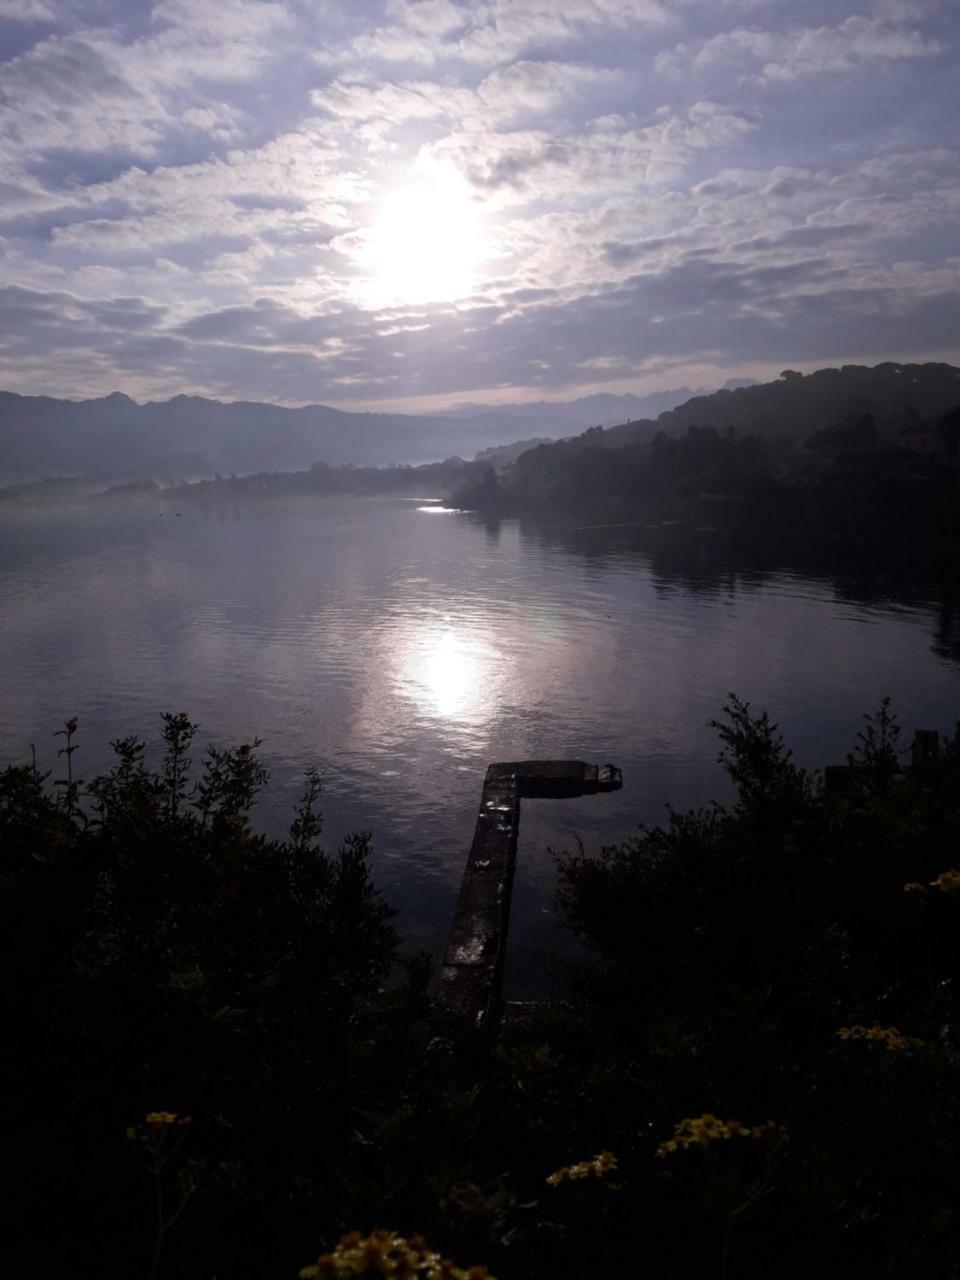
[366,165,485,307]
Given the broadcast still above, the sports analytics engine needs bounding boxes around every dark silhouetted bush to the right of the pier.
[547,698,960,1276]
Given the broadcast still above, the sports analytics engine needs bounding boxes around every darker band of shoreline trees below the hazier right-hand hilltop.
[449,408,960,549]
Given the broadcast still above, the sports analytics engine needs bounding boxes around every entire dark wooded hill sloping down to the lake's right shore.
[449,365,960,554]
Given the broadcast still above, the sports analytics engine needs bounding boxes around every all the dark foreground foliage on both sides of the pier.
[0,699,960,1280]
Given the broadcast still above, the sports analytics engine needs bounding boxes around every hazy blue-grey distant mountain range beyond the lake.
[0,378,747,484]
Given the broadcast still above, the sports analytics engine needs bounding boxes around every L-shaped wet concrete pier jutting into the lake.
[434,760,622,1039]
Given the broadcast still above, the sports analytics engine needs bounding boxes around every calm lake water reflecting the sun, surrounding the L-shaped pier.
[0,498,960,997]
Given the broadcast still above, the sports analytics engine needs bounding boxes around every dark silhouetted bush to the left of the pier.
[0,716,415,1277]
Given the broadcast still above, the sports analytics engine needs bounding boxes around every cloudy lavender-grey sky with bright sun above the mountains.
[0,0,960,411]
